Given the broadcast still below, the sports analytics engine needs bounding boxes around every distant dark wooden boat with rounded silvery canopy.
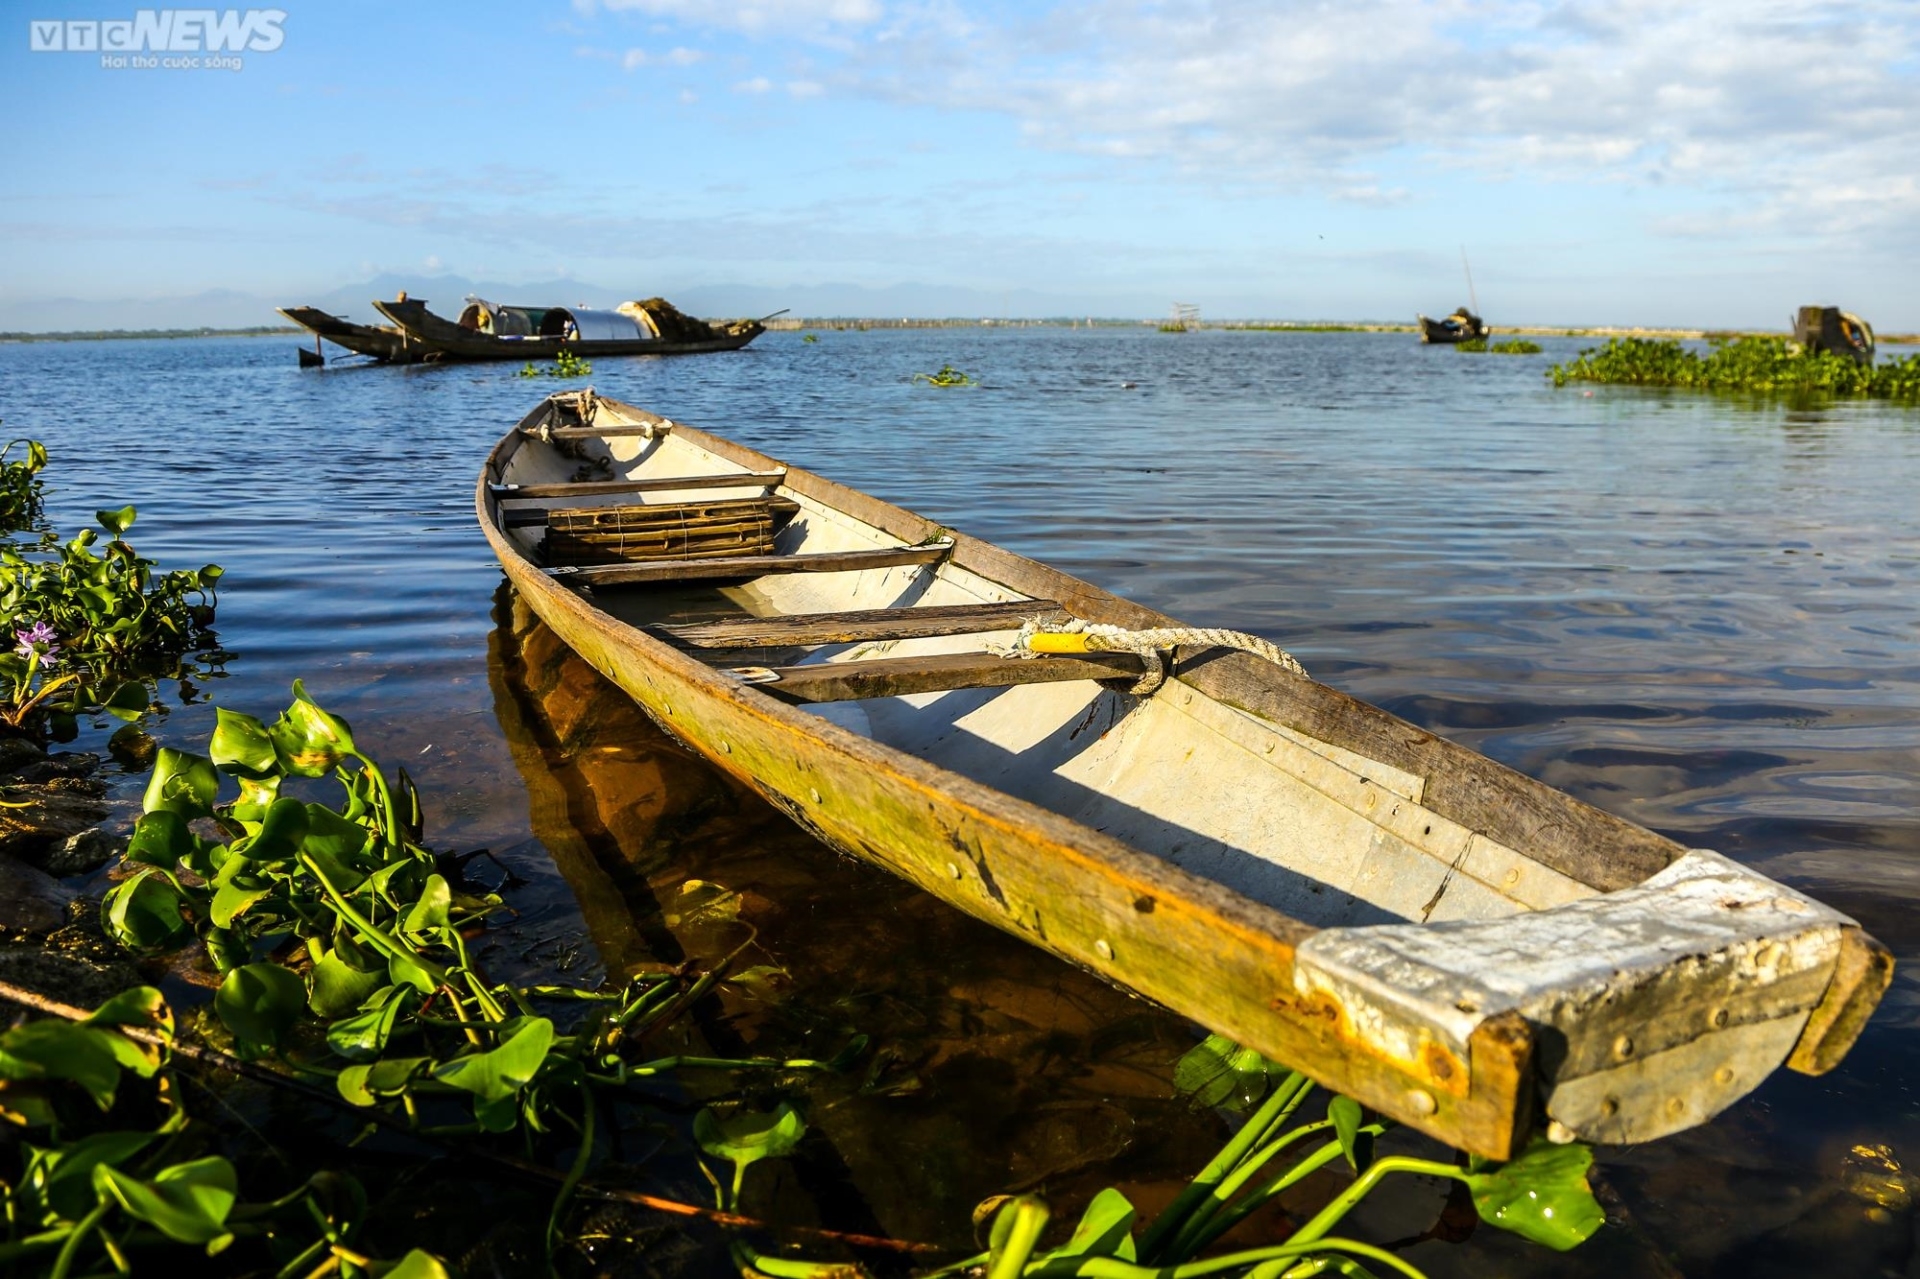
[372,294,772,361]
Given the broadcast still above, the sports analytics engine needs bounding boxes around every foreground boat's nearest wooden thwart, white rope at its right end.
[735,653,1146,701]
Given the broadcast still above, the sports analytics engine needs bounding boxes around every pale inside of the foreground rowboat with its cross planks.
[490,393,1597,928]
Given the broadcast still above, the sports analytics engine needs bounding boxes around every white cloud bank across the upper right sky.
[601,0,1920,232]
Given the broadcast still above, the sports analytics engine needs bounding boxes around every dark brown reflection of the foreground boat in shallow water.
[490,591,1228,1250]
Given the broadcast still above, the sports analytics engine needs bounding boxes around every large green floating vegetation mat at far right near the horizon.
[1548,338,1920,399]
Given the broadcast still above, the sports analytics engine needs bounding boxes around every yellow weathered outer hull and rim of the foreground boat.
[476,391,1891,1158]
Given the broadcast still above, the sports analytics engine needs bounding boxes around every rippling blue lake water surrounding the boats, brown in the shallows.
[0,328,1920,1275]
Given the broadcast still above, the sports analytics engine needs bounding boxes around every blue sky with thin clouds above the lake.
[0,0,1920,330]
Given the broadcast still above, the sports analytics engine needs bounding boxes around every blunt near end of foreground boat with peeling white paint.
[1294,849,1893,1143]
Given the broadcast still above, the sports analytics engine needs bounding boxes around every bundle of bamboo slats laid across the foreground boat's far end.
[540,497,801,565]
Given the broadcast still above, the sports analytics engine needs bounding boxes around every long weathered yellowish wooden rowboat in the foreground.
[476,392,1891,1158]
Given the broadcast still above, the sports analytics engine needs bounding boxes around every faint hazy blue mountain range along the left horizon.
[0,273,1165,332]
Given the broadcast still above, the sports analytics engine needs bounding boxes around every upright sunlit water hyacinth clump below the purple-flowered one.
[82,682,866,1267]
